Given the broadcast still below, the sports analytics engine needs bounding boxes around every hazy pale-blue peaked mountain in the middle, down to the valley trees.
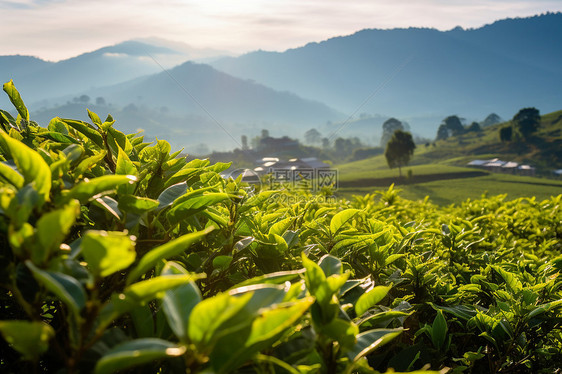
[32,62,344,152]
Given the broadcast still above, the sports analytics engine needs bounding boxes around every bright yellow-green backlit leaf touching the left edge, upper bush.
[0,131,51,202]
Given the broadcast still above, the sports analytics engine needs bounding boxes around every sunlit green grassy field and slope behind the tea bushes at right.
[335,111,562,205]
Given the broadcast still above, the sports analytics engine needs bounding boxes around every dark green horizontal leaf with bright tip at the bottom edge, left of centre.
[94,338,186,374]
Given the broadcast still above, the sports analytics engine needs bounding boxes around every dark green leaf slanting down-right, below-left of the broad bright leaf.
[25,260,86,317]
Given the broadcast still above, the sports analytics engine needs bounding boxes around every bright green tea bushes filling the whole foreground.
[0,82,562,373]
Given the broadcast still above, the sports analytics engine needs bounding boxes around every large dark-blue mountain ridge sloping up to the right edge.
[211,13,562,137]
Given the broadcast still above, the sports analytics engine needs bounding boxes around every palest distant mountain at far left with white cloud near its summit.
[0,38,228,107]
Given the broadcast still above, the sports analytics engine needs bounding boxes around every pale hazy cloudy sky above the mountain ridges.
[0,0,562,61]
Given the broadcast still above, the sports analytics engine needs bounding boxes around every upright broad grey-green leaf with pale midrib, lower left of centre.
[162,261,203,343]
